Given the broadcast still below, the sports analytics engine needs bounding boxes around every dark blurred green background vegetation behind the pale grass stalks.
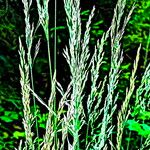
[0,0,150,150]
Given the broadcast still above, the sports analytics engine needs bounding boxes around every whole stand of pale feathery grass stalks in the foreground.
[18,0,150,150]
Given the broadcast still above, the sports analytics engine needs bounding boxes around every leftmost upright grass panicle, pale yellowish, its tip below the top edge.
[19,39,34,150]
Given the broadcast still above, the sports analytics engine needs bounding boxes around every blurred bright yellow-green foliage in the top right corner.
[124,0,150,55]
